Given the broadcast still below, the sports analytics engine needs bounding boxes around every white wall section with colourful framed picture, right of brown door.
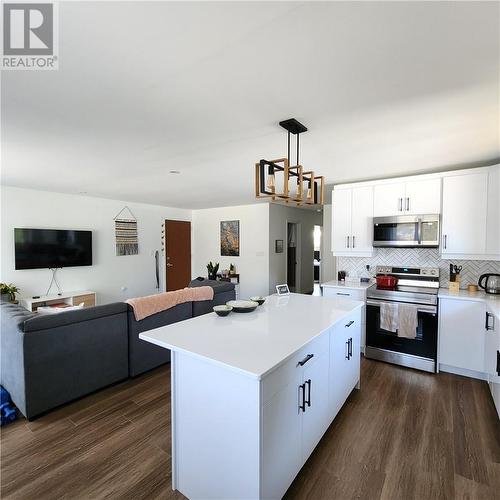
[192,203,269,299]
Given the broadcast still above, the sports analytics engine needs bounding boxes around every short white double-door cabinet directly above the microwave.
[373,178,441,217]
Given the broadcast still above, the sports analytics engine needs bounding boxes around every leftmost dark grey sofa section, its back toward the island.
[0,302,128,419]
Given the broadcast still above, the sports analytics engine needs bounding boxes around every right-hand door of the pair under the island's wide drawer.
[302,352,331,463]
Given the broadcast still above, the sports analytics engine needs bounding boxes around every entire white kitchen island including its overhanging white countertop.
[140,294,363,499]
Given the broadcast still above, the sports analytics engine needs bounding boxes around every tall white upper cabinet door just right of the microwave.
[440,172,488,255]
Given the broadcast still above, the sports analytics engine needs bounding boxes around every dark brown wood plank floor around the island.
[1,359,500,500]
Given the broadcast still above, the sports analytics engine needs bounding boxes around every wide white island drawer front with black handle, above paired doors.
[261,330,330,404]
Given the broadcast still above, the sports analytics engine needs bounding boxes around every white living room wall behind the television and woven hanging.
[0,186,191,304]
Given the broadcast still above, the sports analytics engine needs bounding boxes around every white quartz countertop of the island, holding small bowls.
[139,294,364,379]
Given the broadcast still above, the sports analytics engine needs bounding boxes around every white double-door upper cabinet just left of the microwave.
[332,186,373,257]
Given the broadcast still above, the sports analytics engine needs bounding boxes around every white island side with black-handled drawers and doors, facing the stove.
[261,309,361,499]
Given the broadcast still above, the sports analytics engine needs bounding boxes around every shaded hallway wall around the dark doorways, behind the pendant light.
[269,203,323,293]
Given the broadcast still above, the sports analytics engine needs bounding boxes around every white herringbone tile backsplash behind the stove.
[337,248,500,288]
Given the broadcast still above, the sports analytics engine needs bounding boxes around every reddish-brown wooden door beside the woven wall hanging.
[165,220,191,292]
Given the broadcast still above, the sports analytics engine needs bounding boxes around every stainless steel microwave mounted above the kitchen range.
[373,214,439,248]
